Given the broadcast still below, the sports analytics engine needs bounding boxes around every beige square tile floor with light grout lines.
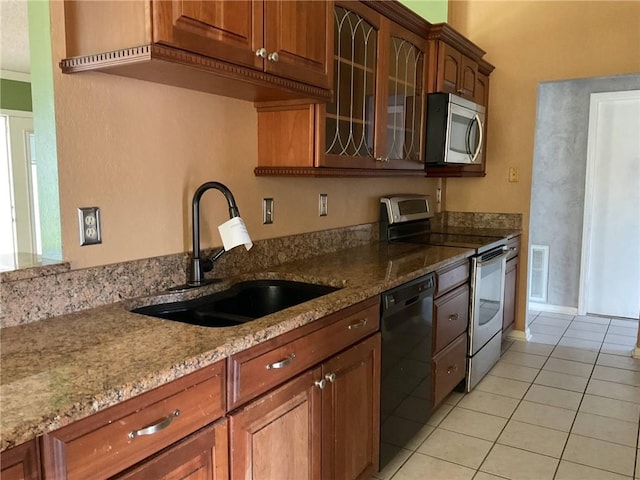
[375,312,640,480]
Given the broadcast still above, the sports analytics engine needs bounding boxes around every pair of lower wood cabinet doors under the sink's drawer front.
[229,334,381,480]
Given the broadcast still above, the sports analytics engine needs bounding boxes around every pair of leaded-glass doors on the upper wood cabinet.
[320,2,426,170]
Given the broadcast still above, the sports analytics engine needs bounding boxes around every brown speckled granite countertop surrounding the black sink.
[0,243,473,451]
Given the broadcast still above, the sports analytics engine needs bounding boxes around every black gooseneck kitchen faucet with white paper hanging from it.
[187,182,240,287]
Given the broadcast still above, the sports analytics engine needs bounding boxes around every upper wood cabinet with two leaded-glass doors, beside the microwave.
[256,1,427,175]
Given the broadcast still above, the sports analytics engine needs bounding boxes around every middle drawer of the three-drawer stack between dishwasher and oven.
[433,285,469,353]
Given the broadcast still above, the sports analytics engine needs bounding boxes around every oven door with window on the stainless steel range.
[470,249,506,355]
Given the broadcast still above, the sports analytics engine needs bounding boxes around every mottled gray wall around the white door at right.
[529,75,640,307]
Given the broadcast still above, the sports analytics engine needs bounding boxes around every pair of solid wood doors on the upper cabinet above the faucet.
[151,0,333,88]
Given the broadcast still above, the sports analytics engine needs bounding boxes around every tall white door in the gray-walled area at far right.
[578,90,640,319]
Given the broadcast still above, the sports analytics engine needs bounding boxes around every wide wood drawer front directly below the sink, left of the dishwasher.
[228,297,380,410]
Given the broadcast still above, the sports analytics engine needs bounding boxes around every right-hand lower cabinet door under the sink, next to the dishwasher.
[322,333,381,480]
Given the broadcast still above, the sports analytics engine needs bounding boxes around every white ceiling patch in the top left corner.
[0,0,31,73]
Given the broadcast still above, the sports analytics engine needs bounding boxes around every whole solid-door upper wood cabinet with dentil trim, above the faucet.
[61,0,333,101]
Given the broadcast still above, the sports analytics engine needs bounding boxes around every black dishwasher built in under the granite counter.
[380,273,435,469]
